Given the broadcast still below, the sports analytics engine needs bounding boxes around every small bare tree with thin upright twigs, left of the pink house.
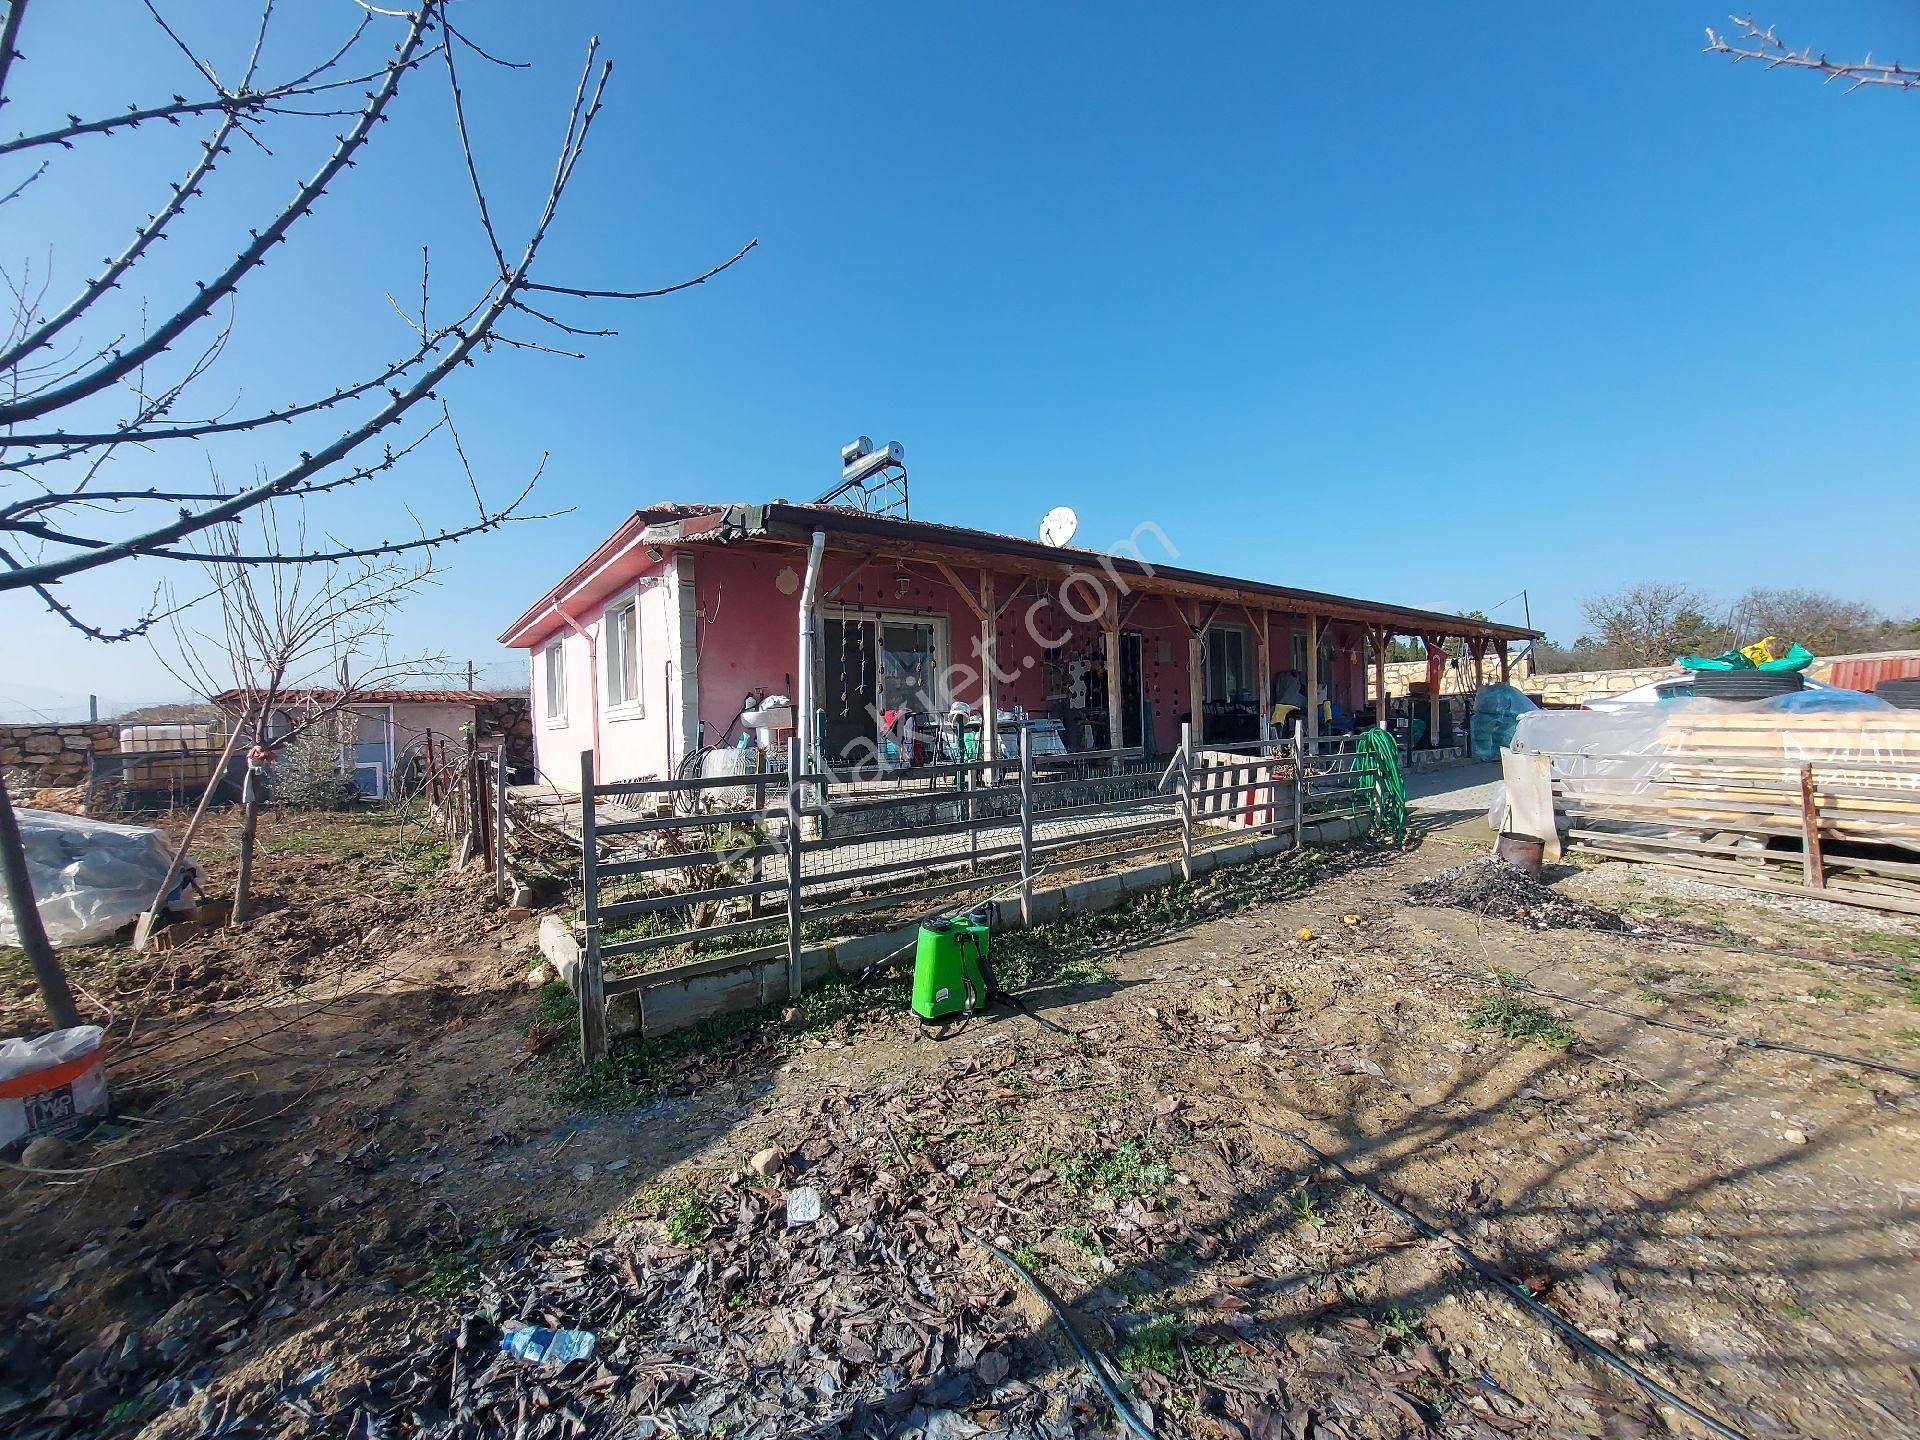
[167,505,444,925]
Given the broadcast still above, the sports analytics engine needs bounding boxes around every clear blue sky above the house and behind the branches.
[0,0,1920,710]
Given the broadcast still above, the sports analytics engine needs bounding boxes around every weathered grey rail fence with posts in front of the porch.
[576,726,1382,1062]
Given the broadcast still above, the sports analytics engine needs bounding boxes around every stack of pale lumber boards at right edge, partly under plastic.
[1553,705,1920,914]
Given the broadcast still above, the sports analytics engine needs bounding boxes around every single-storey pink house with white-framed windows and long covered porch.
[501,501,1534,787]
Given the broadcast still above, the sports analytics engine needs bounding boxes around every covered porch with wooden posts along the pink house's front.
[649,505,1532,768]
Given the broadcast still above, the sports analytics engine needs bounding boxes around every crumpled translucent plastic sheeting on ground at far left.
[0,810,196,945]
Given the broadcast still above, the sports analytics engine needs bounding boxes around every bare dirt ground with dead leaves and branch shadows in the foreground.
[0,806,1920,1440]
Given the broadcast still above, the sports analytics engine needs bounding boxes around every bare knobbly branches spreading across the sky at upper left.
[0,0,755,639]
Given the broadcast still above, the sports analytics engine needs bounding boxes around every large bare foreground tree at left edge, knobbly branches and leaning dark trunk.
[0,0,753,1012]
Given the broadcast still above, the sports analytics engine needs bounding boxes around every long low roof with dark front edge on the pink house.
[501,501,1540,645]
